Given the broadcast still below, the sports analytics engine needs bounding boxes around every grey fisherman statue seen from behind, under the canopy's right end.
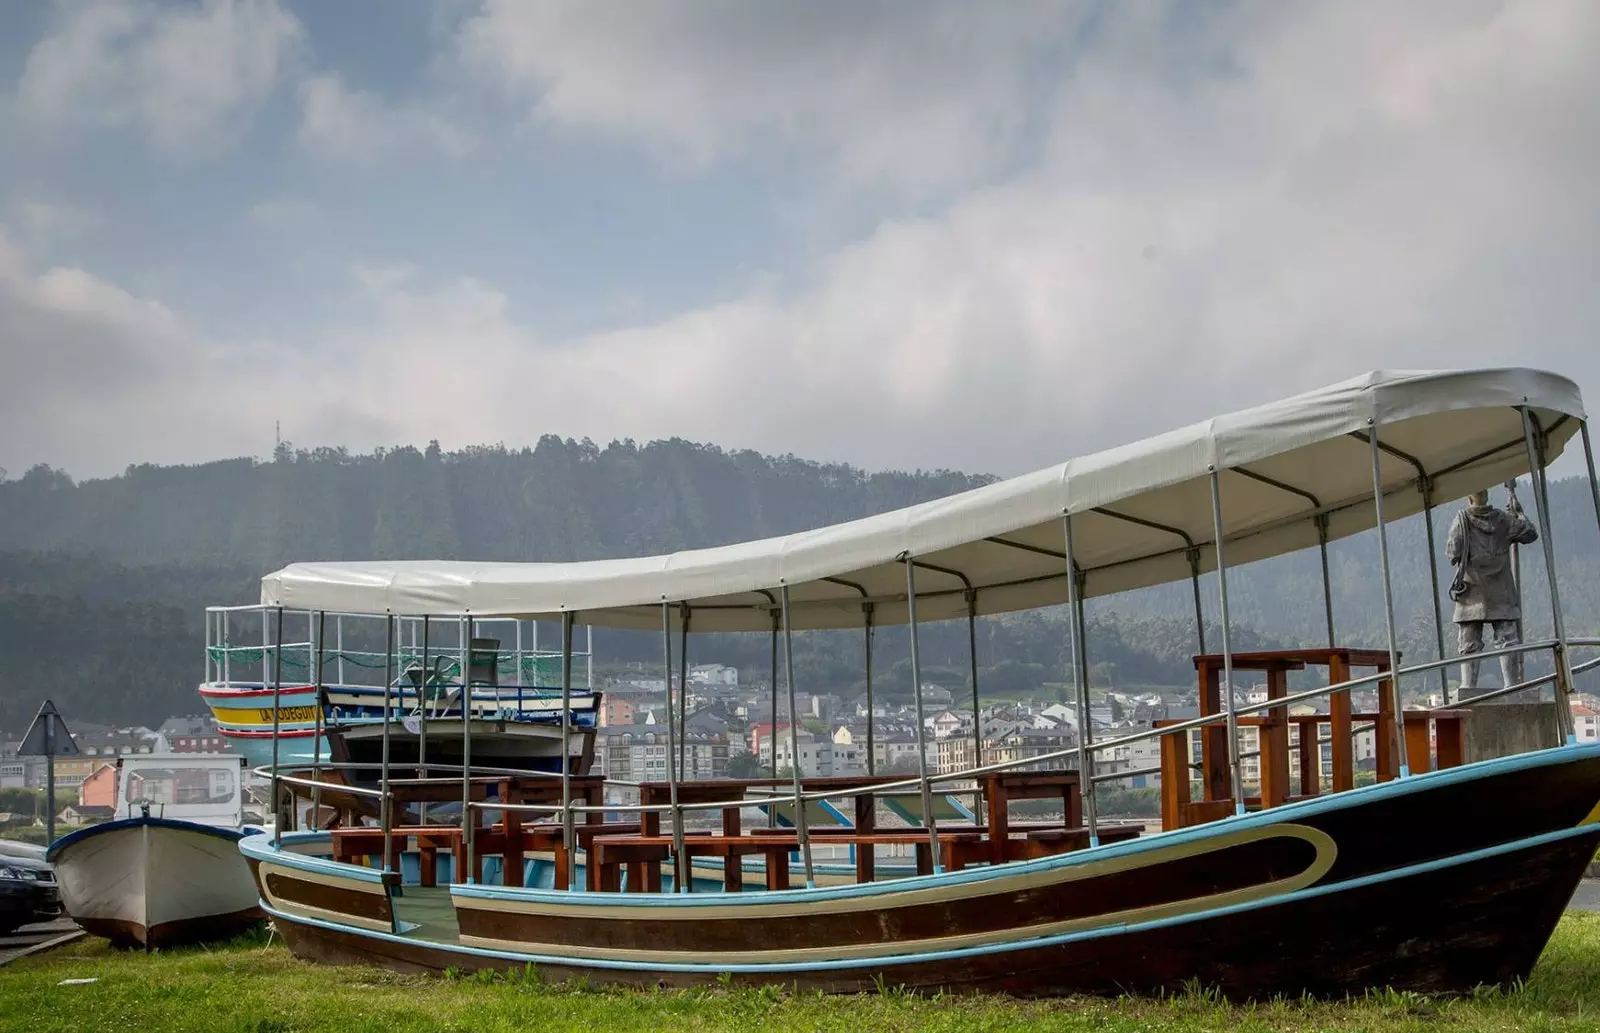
[1445,483,1539,689]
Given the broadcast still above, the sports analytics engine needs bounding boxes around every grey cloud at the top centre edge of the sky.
[458,0,1085,192]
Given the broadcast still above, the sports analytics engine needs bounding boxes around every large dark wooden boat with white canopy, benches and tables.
[216,369,1600,998]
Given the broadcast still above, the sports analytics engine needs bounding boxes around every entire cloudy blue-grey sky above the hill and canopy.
[0,0,1600,477]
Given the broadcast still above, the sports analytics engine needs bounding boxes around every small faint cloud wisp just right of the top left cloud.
[299,74,474,162]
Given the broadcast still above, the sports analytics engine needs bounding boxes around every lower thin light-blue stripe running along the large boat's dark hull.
[272,818,1600,974]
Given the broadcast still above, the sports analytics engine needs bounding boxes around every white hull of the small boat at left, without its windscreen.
[50,817,266,950]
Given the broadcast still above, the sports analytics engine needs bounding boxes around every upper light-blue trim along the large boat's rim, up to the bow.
[451,742,1600,910]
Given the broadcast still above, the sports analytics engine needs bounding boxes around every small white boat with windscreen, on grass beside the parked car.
[46,753,264,950]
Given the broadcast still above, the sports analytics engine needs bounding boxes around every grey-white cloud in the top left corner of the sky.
[18,0,302,154]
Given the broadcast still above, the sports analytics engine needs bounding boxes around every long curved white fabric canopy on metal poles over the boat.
[261,369,1584,632]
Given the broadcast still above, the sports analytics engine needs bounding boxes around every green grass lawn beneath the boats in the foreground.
[9,913,1600,1033]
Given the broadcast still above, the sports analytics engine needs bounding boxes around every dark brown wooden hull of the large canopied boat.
[245,747,1600,998]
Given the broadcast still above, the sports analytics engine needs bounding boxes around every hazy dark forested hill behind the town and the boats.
[0,437,1600,731]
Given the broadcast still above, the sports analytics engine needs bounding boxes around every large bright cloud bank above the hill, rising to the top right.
[0,0,1600,473]
